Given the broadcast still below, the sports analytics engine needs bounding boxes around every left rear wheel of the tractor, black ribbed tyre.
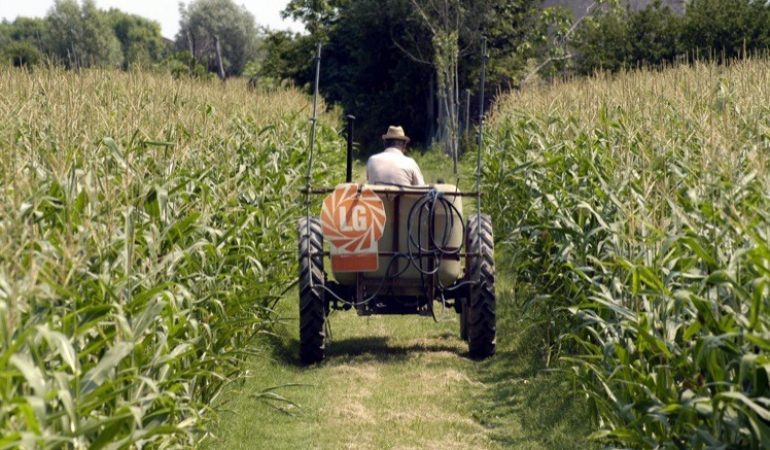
[299,217,326,364]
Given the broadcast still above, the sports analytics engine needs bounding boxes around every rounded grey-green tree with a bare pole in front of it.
[176,0,257,75]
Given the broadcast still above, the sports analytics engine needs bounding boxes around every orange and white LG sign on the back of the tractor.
[321,184,385,272]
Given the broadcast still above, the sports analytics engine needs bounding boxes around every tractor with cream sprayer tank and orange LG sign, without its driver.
[298,46,496,364]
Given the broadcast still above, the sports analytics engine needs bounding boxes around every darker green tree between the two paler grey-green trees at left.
[106,9,166,69]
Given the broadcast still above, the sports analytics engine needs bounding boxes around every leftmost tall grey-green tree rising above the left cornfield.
[47,0,123,68]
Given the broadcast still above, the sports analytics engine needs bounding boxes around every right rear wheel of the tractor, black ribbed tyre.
[460,213,497,358]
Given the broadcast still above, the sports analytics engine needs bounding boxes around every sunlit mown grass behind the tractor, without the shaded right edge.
[208,298,489,449]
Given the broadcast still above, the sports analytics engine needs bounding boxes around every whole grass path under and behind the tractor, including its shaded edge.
[206,272,589,450]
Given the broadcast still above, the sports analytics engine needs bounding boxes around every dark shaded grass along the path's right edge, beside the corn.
[474,284,595,449]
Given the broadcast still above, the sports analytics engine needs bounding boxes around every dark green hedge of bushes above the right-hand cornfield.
[571,0,770,74]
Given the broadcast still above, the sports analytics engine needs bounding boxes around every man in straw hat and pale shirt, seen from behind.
[366,126,425,186]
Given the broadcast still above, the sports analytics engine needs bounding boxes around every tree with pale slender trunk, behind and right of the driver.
[382,0,548,155]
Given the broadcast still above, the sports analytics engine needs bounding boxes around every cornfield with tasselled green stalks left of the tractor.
[0,70,341,449]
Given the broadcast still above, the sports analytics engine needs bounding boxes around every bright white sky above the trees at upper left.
[0,0,304,38]
